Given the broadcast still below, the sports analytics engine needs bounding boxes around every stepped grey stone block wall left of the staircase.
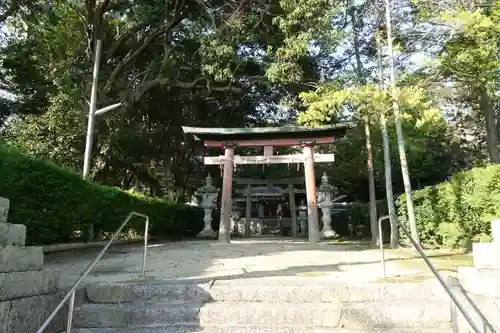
[0,198,80,333]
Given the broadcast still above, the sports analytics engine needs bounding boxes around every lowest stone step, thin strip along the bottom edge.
[67,326,453,333]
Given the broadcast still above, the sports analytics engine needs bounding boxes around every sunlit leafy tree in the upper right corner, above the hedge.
[410,1,500,163]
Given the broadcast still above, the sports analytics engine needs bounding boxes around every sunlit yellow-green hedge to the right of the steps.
[397,165,500,247]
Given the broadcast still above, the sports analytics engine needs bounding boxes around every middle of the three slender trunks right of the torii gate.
[376,33,399,249]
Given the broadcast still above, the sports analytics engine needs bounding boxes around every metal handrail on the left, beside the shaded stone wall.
[36,212,149,333]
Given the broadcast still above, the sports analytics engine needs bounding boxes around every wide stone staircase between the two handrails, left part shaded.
[69,279,452,333]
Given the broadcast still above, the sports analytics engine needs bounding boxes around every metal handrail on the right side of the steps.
[378,215,482,333]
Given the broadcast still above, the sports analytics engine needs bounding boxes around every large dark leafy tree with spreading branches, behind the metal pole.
[1,0,316,195]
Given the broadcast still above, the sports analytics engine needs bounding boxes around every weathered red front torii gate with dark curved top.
[182,122,354,243]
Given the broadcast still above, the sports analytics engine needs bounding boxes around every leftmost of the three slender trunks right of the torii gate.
[351,8,380,245]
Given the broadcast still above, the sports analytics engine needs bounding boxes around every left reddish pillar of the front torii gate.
[219,144,234,243]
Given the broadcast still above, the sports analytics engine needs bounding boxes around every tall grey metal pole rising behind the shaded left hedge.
[82,39,102,242]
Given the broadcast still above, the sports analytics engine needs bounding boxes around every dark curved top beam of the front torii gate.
[182,122,354,141]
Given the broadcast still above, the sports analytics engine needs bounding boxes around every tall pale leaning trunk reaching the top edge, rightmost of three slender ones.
[385,0,420,243]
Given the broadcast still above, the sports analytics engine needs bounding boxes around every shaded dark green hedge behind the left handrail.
[0,146,203,244]
